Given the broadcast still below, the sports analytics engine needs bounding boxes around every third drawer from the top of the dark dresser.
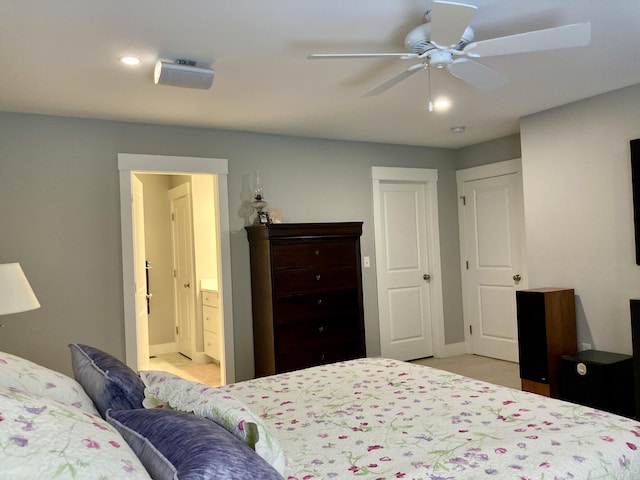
[274,288,359,324]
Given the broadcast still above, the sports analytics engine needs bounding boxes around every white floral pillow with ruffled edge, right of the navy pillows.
[140,371,286,474]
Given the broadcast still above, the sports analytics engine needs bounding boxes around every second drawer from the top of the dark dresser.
[273,266,358,295]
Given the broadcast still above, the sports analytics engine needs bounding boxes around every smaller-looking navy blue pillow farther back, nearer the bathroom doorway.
[69,343,144,418]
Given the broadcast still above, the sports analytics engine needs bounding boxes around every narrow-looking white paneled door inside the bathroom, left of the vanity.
[169,184,196,358]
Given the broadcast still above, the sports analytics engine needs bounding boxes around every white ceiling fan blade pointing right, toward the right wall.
[464,23,591,57]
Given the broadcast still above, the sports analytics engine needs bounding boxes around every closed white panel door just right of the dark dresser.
[374,169,441,360]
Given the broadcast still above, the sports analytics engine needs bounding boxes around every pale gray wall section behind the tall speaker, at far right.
[520,81,640,354]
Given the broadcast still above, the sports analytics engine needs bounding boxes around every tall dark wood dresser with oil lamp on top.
[246,222,366,376]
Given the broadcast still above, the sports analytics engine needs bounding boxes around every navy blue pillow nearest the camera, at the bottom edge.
[107,409,282,480]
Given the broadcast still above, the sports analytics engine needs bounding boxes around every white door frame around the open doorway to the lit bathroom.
[118,153,235,385]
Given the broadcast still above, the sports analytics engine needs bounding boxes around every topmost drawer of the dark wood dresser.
[271,240,357,268]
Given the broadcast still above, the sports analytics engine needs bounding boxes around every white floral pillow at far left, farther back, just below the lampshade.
[0,352,98,414]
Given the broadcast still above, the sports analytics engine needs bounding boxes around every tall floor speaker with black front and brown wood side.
[516,288,578,398]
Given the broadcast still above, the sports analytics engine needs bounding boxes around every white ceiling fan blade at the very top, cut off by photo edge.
[430,1,478,48]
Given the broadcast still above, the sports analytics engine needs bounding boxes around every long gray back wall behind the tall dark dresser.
[0,113,464,379]
